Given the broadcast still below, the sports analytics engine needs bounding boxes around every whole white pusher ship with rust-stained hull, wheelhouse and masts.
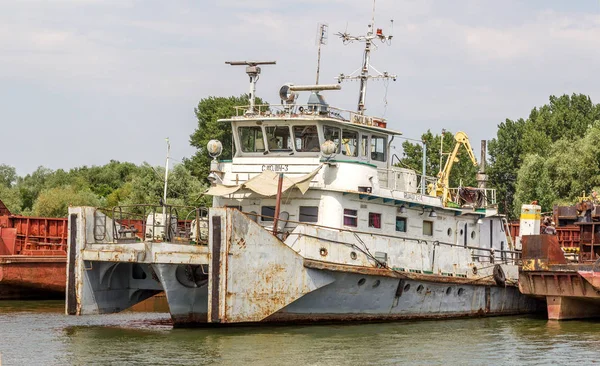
[66,14,538,326]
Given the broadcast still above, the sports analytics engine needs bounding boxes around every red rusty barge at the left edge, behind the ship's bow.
[0,201,68,300]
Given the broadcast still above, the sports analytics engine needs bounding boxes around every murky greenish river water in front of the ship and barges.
[0,301,600,366]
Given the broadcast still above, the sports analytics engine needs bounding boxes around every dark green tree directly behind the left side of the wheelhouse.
[184,94,264,182]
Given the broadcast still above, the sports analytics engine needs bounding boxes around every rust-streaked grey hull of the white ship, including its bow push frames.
[66,207,537,326]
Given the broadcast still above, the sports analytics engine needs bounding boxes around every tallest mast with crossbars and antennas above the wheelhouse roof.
[336,0,397,114]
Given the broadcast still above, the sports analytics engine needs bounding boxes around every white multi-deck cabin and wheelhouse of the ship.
[208,98,507,256]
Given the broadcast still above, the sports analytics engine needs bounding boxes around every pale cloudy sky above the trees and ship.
[0,0,600,175]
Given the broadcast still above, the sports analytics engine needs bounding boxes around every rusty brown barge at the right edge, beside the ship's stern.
[519,199,600,320]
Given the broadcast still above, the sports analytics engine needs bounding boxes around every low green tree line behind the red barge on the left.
[0,160,210,217]
